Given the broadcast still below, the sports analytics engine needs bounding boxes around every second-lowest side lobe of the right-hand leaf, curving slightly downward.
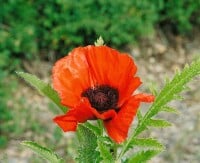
[129,138,164,150]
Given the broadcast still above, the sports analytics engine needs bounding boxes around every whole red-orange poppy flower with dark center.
[52,45,154,143]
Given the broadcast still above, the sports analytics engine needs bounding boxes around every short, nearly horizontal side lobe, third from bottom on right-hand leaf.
[146,119,172,127]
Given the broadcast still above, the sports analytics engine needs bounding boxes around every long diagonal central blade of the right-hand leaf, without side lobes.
[118,59,200,158]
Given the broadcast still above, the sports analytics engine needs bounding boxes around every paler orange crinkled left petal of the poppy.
[52,47,93,107]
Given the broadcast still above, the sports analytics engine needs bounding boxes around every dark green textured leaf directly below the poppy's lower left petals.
[76,124,101,163]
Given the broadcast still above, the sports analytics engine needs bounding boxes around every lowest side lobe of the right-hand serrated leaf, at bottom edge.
[128,150,160,163]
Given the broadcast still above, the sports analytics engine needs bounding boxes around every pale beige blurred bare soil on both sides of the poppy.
[0,32,200,163]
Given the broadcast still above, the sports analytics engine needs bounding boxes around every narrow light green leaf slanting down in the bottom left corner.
[21,141,64,163]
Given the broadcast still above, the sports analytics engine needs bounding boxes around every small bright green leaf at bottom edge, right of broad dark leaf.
[97,140,114,163]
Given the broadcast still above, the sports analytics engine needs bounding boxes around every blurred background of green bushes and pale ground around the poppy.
[0,0,200,163]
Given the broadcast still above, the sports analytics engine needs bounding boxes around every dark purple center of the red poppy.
[82,85,119,112]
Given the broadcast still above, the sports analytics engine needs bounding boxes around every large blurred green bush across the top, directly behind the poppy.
[0,0,158,59]
